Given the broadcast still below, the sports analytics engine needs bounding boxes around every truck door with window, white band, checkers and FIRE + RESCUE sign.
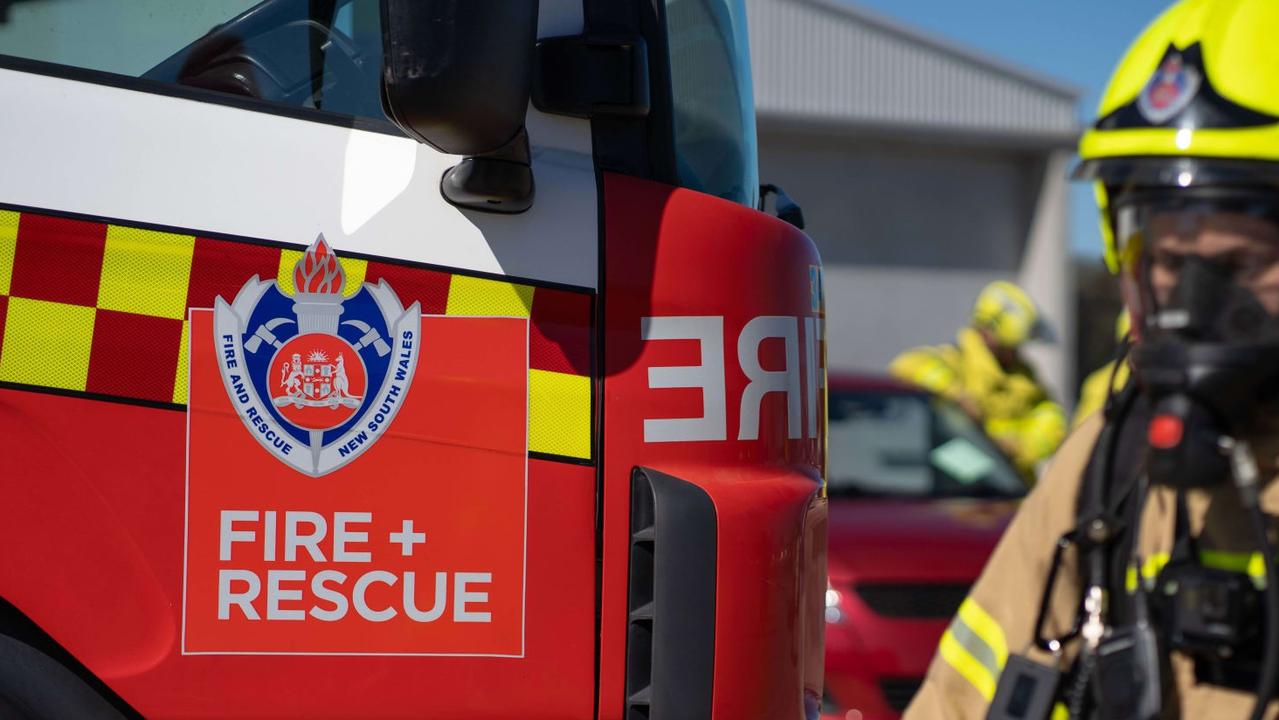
[0,0,600,719]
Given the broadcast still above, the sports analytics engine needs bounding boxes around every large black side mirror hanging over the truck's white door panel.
[381,0,537,212]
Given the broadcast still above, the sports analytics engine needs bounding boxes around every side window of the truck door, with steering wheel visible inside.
[0,0,385,119]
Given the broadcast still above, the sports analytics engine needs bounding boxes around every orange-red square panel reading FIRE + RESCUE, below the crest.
[180,311,526,657]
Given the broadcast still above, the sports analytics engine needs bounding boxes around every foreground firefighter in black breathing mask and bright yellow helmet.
[906,0,1279,720]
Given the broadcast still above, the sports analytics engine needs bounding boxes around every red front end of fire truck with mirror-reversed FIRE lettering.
[560,0,826,720]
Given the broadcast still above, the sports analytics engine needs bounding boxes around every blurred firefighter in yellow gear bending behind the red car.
[889,280,1065,481]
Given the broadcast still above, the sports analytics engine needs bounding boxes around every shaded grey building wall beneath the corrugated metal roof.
[760,130,1073,399]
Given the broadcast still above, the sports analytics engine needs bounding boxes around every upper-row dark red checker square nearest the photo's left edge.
[9,212,106,306]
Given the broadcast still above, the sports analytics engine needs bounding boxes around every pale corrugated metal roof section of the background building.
[746,0,1081,145]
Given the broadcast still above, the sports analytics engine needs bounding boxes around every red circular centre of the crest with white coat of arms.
[267,333,367,430]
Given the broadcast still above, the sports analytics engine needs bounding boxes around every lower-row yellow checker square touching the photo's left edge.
[0,298,97,390]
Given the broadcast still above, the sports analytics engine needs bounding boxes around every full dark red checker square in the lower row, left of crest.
[84,309,182,403]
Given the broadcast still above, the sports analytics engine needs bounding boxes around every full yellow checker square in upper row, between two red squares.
[97,225,196,320]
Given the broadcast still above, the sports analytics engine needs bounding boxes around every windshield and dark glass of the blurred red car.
[828,390,1026,497]
